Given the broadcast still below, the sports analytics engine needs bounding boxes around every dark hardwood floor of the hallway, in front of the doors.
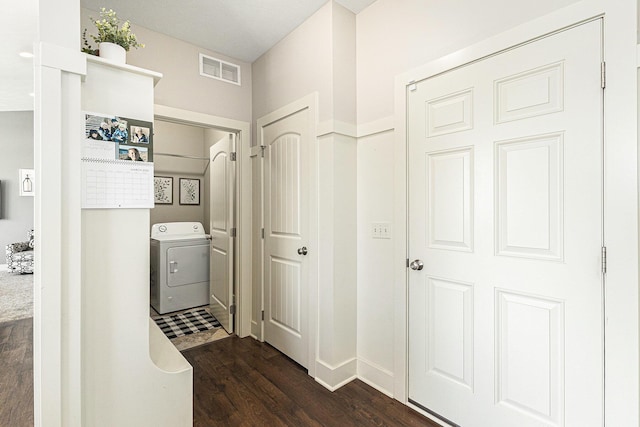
[183,336,437,427]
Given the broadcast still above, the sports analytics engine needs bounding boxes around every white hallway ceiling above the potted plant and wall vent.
[81,0,375,63]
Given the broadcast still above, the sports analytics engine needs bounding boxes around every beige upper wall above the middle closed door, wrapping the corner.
[252,2,356,124]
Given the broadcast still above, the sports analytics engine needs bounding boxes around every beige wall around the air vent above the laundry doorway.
[81,9,252,122]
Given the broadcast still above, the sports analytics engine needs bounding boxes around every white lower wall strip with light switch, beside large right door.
[357,131,395,394]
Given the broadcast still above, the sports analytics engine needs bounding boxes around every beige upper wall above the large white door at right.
[357,0,577,124]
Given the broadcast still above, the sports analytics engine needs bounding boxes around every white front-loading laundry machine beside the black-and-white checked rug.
[150,222,210,314]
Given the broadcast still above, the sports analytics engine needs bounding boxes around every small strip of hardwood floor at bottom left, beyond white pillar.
[0,318,33,427]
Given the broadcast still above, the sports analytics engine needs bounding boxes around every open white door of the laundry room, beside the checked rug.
[209,134,236,333]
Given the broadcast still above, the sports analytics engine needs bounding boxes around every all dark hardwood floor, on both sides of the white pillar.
[0,319,437,427]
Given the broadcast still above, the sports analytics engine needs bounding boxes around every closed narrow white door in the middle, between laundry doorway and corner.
[261,109,310,367]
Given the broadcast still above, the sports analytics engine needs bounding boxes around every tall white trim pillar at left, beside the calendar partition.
[33,37,86,426]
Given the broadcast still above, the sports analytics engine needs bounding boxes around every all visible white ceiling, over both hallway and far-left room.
[0,0,375,111]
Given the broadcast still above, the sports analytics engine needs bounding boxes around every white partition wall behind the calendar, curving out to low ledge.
[79,58,193,427]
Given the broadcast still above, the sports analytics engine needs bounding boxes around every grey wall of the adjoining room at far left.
[0,111,34,254]
